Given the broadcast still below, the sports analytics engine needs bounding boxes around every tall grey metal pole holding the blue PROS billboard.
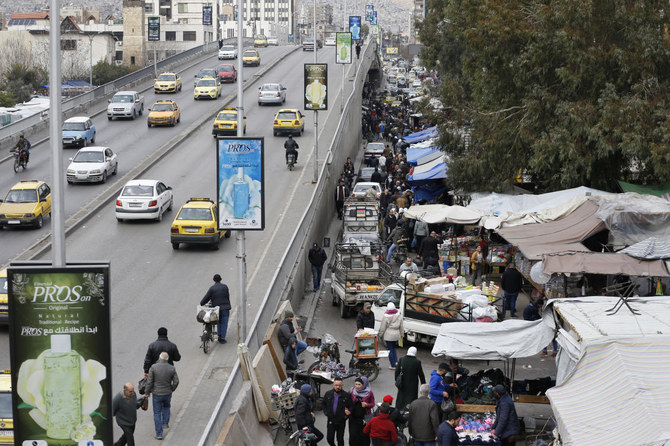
[235,0,247,344]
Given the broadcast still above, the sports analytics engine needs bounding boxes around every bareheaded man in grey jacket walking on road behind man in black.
[146,352,179,440]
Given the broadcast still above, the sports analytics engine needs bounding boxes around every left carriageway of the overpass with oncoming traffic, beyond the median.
[0,46,288,265]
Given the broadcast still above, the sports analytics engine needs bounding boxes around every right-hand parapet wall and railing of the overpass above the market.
[198,37,377,446]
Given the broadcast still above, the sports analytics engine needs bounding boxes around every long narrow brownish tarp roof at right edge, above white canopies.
[542,252,669,277]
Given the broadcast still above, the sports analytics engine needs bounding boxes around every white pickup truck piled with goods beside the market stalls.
[372,275,474,343]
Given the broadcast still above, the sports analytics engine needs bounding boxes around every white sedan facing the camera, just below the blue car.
[66,146,119,184]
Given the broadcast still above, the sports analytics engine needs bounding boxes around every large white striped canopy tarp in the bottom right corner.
[547,338,670,446]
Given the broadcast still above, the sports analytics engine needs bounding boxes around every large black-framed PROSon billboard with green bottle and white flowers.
[7,263,114,446]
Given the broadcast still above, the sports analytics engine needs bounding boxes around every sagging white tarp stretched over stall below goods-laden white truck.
[431,311,556,360]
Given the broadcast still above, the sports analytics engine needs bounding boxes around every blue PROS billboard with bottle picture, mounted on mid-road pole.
[216,138,265,231]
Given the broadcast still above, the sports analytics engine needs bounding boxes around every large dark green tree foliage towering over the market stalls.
[418,0,670,190]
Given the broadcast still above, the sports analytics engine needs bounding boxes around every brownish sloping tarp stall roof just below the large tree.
[497,201,605,260]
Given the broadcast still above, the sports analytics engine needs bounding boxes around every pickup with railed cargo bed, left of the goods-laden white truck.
[330,241,391,318]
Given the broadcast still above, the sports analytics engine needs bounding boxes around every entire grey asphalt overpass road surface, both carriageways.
[0,43,354,446]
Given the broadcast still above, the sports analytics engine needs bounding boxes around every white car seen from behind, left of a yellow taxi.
[116,180,173,221]
